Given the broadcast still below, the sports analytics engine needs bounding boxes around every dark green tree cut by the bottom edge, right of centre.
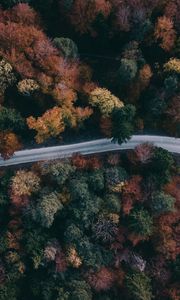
[125,270,153,300]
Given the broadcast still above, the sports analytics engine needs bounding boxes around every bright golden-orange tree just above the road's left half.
[27,106,64,144]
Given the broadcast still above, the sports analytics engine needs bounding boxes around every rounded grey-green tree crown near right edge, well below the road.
[151,192,176,215]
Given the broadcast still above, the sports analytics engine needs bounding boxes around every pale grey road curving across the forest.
[0,135,180,167]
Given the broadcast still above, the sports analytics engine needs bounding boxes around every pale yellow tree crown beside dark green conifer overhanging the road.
[89,88,124,117]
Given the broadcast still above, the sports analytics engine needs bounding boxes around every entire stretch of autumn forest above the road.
[0,0,180,159]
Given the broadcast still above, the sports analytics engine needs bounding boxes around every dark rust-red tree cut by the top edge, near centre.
[69,0,111,35]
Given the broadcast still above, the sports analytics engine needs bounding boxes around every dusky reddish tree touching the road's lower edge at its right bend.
[128,143,154,165]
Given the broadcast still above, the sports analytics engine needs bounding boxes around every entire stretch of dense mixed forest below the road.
[0,144,180,300]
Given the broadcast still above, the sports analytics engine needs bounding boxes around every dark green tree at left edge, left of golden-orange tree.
[0,107,25,133]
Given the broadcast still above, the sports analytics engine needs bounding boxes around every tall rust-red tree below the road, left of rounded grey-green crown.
[122,175,143,215]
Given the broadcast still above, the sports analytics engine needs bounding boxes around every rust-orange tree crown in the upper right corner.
[154,16,176,51]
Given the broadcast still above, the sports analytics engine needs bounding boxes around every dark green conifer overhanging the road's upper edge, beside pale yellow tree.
[112,104,136,144]
